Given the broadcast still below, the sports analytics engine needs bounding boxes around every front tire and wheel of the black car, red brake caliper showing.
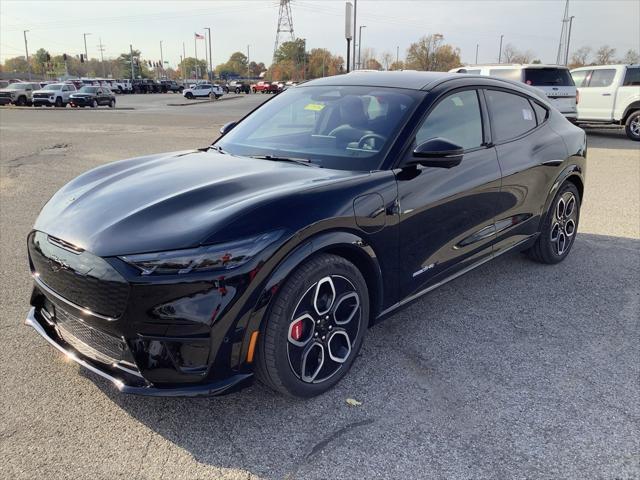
[256,253,369,398]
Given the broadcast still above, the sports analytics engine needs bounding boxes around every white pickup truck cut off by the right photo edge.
[571,65,640,141]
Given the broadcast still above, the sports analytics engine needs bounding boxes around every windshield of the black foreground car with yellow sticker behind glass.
[216,86,422,171]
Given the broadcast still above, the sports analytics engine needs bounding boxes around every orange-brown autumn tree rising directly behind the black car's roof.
[405,33,461,72]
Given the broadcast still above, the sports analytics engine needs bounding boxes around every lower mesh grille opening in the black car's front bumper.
[55,307,127,364]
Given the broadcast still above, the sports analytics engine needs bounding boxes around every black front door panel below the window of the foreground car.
[397,147,500,296]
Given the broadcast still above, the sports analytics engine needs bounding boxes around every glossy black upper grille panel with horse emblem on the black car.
[29,232,129,318]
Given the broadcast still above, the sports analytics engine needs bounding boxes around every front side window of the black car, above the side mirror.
[416,90,483,150]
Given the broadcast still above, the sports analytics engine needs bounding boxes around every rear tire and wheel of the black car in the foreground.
[526,182,581,264]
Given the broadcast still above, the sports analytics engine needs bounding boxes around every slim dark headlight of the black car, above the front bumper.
[119,231,282,275]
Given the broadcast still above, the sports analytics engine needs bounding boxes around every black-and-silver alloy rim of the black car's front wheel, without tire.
[287,275,362,383]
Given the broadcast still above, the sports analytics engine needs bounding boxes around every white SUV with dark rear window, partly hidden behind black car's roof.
[449,63,578,122]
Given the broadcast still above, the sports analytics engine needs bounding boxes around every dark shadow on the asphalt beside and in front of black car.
[87,234,640,479]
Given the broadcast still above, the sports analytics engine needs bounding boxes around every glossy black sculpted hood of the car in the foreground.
[34,150,353,256]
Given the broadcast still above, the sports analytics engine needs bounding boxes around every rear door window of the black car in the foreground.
[486,90,537,142]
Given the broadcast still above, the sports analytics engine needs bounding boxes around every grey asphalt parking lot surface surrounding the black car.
[0,94,640,480]
